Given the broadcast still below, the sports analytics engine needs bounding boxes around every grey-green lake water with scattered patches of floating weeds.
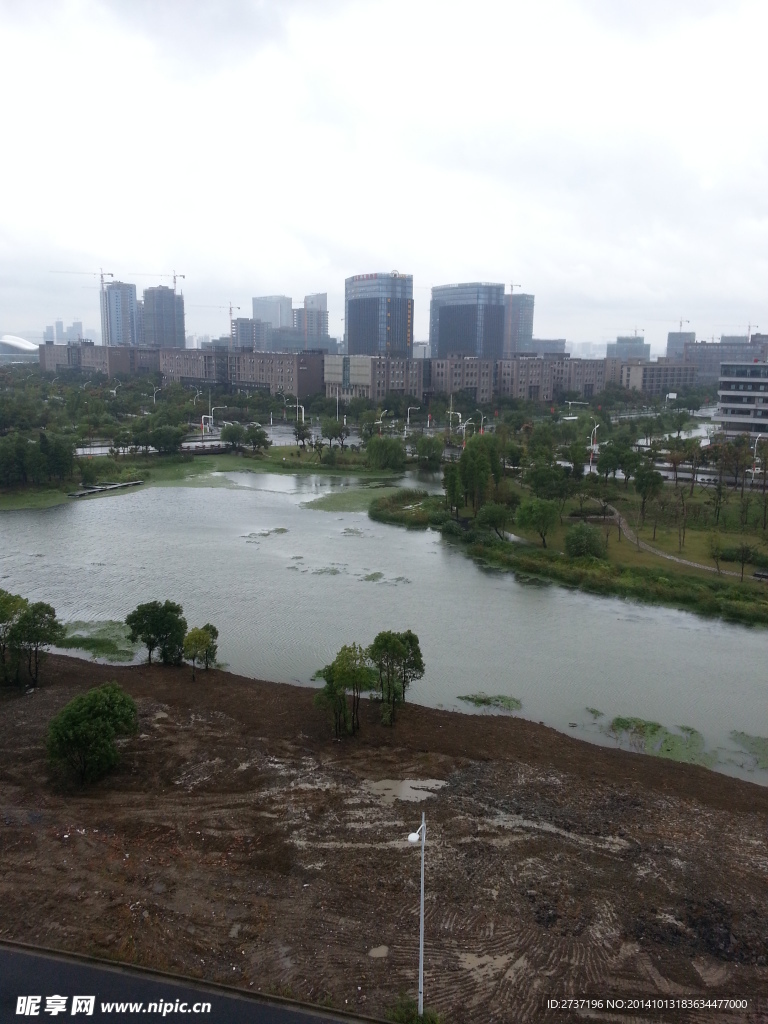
[0,473,768,783]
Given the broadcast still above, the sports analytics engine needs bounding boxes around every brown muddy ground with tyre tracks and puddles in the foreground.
[0,656,768,1022]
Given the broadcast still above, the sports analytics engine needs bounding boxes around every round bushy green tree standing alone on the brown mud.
[47,683,138,784]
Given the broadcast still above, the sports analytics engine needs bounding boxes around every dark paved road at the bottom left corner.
[0,943,372,1024]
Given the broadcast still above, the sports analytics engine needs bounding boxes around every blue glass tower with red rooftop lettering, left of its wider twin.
[344,270,414,358]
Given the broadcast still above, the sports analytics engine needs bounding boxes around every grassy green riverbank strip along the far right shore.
[369,490,768,626]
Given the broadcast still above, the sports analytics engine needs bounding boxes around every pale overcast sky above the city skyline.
[0,0,768,352]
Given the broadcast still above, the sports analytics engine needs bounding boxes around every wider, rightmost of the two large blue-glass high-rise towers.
[429,282,504,359]
